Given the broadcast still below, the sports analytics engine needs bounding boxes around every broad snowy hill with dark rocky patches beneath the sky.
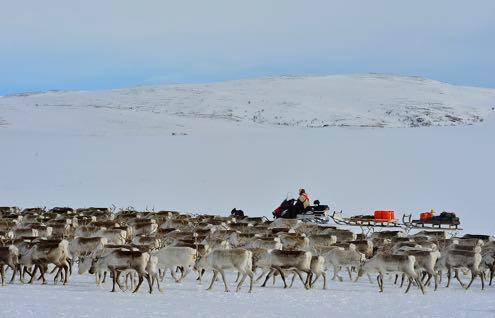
[0,74,495,127]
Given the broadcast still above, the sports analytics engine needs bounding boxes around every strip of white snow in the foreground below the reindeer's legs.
[0,274,495,318]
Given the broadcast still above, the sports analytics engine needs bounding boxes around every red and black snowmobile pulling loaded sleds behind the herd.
[272,199,330,224]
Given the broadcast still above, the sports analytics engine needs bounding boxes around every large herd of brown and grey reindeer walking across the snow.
[0,207,495,293]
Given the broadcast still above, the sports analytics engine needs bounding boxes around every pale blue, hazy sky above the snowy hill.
[0,0,495,95]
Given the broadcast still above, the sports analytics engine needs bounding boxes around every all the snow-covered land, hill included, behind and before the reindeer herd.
[0,75,495,317]
